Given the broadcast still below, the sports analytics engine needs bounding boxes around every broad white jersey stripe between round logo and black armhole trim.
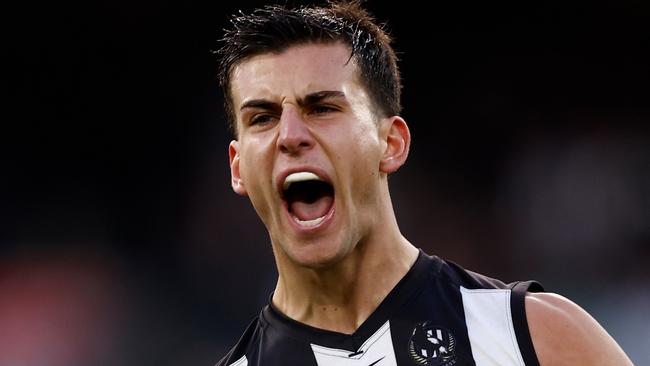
[460,286,524,366]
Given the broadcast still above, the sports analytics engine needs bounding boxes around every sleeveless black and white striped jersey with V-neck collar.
[217,251,543,366]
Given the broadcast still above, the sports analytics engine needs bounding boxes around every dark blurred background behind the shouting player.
[0,0,650,366]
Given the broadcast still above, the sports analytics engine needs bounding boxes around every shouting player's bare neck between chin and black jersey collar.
[273,224,418,334]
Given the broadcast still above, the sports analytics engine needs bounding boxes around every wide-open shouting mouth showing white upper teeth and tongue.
[282,172,334,227]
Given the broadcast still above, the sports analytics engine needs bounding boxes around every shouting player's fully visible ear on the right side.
[379,116,411,174]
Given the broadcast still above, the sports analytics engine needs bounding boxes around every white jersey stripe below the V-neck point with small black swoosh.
[311,321,397,366]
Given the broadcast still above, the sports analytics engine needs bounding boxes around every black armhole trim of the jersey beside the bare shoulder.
[510,281,544,366]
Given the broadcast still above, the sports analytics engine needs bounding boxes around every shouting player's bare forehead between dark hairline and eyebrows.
[231,43,361,106]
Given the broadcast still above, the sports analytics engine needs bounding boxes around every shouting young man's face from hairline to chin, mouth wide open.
[229,43,394,267]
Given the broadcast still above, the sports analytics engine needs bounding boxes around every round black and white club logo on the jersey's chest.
[409,321,456,366]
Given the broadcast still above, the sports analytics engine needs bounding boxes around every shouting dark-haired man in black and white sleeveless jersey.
[217,3,631,366]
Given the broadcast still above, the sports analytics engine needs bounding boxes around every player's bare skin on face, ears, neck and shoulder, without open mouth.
[229,43,631,365]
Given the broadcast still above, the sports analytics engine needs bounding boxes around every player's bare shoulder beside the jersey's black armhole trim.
[526,293,632,366]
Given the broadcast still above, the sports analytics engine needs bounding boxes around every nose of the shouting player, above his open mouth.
[277,106,314,155]
